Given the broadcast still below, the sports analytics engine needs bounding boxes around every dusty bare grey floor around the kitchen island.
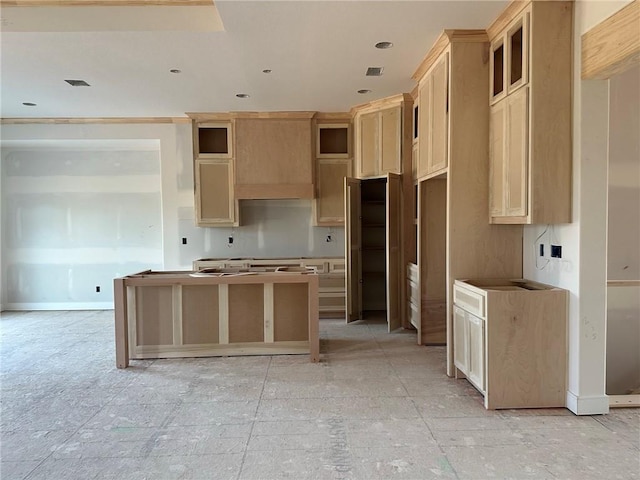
[0,311,640,480]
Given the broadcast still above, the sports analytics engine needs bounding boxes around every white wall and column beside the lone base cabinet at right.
[524,0,629,414]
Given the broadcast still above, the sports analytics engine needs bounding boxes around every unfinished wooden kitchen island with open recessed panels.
[114,270,320,368]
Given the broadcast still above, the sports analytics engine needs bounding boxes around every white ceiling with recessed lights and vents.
[0,0,509,118]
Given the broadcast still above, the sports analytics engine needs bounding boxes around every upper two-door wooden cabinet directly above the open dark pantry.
[352,94,412,178]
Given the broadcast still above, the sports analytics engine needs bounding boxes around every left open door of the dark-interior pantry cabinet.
[344,177,362,323]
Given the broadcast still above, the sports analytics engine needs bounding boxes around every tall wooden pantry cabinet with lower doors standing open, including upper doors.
[345,94,413,331]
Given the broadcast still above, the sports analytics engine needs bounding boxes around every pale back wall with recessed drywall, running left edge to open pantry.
[0,119,344,308]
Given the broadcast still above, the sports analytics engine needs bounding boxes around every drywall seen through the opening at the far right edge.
[606,67,640,395]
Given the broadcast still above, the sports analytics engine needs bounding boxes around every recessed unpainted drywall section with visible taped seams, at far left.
[2,140,162,309]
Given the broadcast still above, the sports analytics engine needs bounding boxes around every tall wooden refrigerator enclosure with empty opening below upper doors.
[413,30,522,375]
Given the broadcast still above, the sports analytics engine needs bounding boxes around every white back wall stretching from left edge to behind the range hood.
[0,124,344,308]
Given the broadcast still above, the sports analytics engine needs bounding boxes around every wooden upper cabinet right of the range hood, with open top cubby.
[313,118,352,227]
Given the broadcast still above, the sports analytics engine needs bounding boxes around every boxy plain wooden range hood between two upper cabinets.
[235,112,315,199]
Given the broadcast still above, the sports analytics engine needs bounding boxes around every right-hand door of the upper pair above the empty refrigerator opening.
[428,53,449,173]
